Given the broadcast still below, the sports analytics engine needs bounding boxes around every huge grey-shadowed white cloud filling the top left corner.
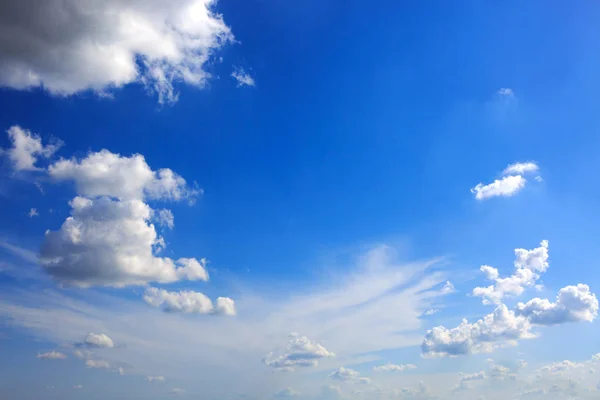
[0,0,233,102]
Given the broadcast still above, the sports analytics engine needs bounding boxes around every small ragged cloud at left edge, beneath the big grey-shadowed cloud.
[0,124,63,171]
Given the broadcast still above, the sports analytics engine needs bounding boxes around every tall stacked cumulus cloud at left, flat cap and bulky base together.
[40,150,208,287]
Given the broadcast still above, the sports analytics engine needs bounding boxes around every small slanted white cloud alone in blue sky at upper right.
[471,162,539,200]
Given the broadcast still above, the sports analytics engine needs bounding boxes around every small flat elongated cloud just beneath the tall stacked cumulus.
[144,288,236,315]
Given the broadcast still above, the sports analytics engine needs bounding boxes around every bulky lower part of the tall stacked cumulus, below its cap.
[40,197,208,287]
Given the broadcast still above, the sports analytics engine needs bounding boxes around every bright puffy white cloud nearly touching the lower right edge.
[516,283,598,325]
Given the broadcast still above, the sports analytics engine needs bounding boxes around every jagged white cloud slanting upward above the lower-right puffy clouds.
[472,240,549,304]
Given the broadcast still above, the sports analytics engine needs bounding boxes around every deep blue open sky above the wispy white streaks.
[0,0,600,400]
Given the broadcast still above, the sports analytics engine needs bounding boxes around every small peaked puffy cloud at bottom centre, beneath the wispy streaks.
[263,333,335,371]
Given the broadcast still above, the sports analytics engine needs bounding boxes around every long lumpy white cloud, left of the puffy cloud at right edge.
[421,304,535,357]
